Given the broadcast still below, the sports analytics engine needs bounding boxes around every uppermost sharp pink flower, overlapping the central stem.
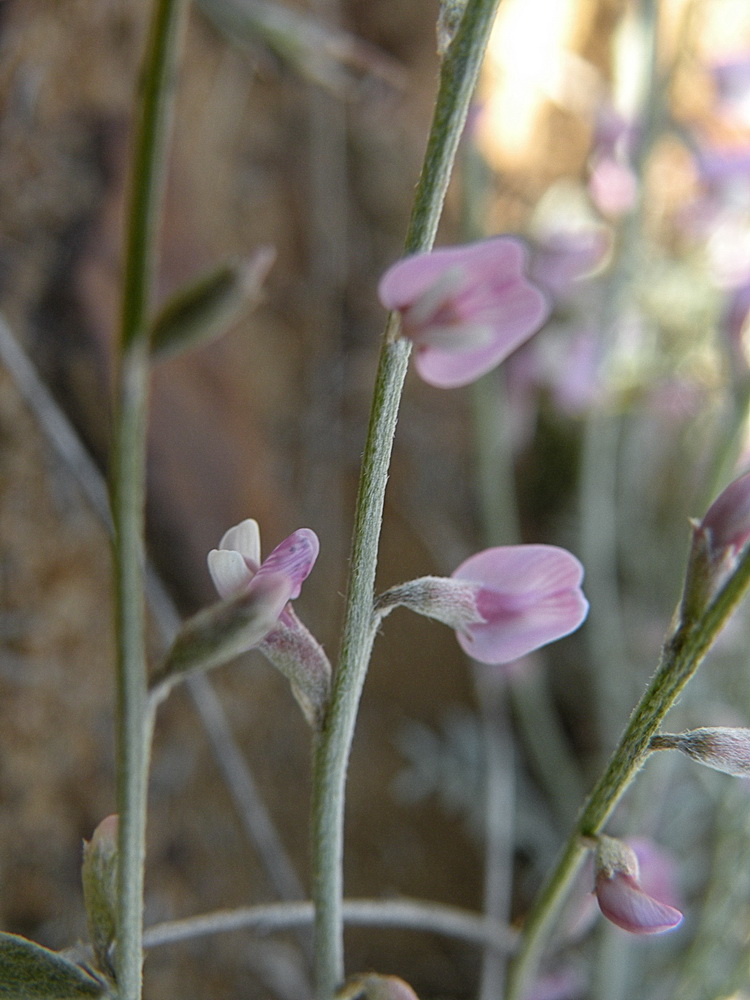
[378,236,548,389]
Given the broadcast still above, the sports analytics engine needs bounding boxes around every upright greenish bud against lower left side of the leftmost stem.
[81,815,119,977]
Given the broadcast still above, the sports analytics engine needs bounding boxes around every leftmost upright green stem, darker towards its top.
[112,0,186,1000]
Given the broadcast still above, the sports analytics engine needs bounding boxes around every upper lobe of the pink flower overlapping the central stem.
[378,236,525,309]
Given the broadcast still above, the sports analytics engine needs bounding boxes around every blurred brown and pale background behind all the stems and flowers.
[0,0,750,1000]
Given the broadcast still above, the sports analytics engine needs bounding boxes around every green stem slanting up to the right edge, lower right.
[506,548,750,1000]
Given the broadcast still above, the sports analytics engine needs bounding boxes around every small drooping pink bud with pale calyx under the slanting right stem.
[595,836,682,934]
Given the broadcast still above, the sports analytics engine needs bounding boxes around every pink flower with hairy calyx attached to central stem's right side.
[377,545,588,664]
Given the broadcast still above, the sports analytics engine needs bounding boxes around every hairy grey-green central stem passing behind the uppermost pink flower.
[312,0,498,1000]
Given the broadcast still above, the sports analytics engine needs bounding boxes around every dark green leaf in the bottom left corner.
[0,934,110,1000]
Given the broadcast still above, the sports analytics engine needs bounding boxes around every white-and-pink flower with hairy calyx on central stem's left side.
[208,518,331,726]
